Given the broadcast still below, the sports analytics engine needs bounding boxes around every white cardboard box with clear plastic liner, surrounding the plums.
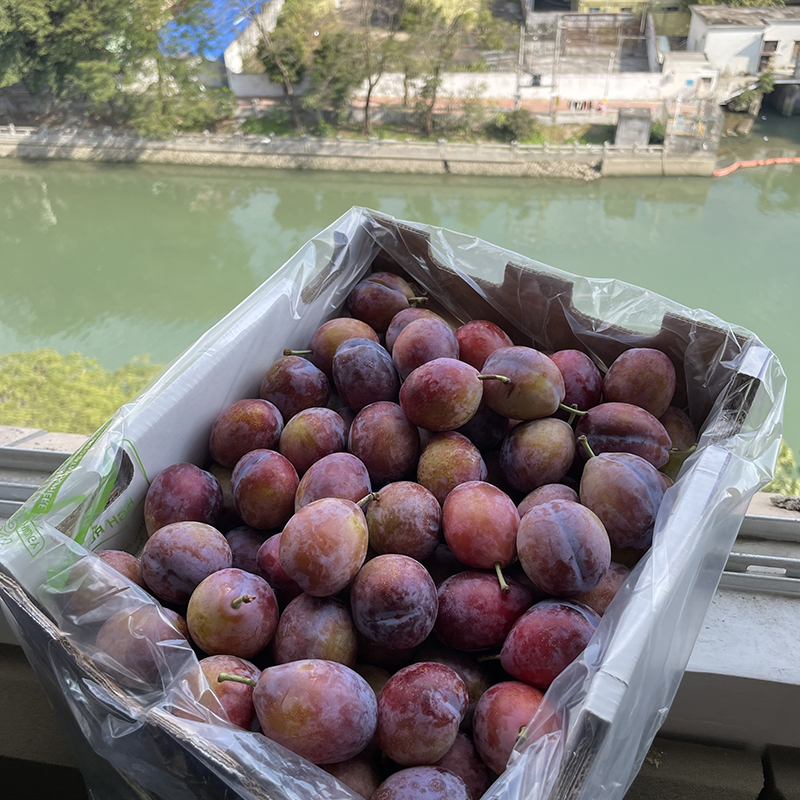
[0,208,785,800]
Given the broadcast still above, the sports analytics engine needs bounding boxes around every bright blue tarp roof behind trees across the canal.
[161,0,269,61]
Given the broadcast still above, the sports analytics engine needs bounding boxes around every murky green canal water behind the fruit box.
[0,118,800,448]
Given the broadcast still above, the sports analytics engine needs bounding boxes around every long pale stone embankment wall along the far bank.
[0,127,715,180]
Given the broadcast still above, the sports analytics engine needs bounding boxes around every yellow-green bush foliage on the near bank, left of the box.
[0,350,161,433]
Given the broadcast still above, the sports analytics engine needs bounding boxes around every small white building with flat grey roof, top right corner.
[687,6,800,75]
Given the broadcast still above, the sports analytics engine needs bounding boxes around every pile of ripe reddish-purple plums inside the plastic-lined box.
[90,273,695,800]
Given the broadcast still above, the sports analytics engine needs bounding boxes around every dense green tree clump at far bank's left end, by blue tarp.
[0,0,232,136]
